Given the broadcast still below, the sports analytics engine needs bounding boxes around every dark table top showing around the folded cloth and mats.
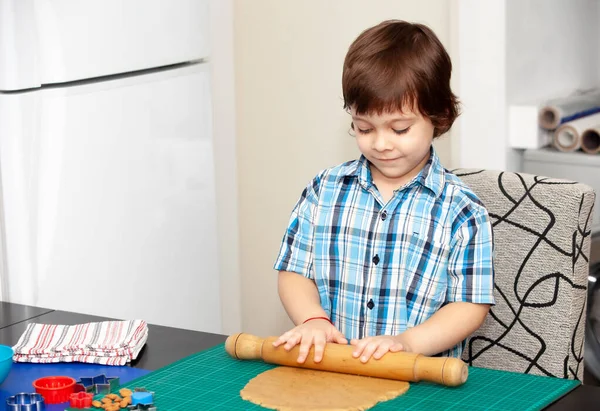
[0,303,600,411]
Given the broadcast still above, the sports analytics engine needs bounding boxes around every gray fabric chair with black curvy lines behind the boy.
[452,169,595,380]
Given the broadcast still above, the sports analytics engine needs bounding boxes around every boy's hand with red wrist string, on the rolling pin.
[273,319,348,364]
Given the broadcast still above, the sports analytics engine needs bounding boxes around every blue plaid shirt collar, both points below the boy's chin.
[340,146,446,197]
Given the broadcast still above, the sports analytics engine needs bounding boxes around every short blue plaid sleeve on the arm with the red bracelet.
[274,176,320,279]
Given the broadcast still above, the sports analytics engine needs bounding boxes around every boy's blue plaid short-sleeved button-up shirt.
[274,148,494,357]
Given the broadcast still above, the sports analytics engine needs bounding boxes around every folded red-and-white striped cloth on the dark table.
[13,320,148,365]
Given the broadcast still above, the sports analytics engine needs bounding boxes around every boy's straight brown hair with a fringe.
[342,20,459,137]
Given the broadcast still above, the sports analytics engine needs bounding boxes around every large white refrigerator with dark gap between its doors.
[0,0,221,332]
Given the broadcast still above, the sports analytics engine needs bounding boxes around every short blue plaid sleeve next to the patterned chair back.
[446,205,495,305]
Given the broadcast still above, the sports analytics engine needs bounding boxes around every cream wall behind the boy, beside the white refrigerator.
[232,0,450,335]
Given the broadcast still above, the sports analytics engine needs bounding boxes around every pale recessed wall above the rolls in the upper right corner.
[506,0,600,104]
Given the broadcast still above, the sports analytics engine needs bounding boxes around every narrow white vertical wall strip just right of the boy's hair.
[451,0,507,169]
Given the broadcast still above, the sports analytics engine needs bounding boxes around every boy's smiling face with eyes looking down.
[351,109,434,185]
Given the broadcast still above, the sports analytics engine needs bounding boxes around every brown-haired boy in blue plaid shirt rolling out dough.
[274,21,494,363]
